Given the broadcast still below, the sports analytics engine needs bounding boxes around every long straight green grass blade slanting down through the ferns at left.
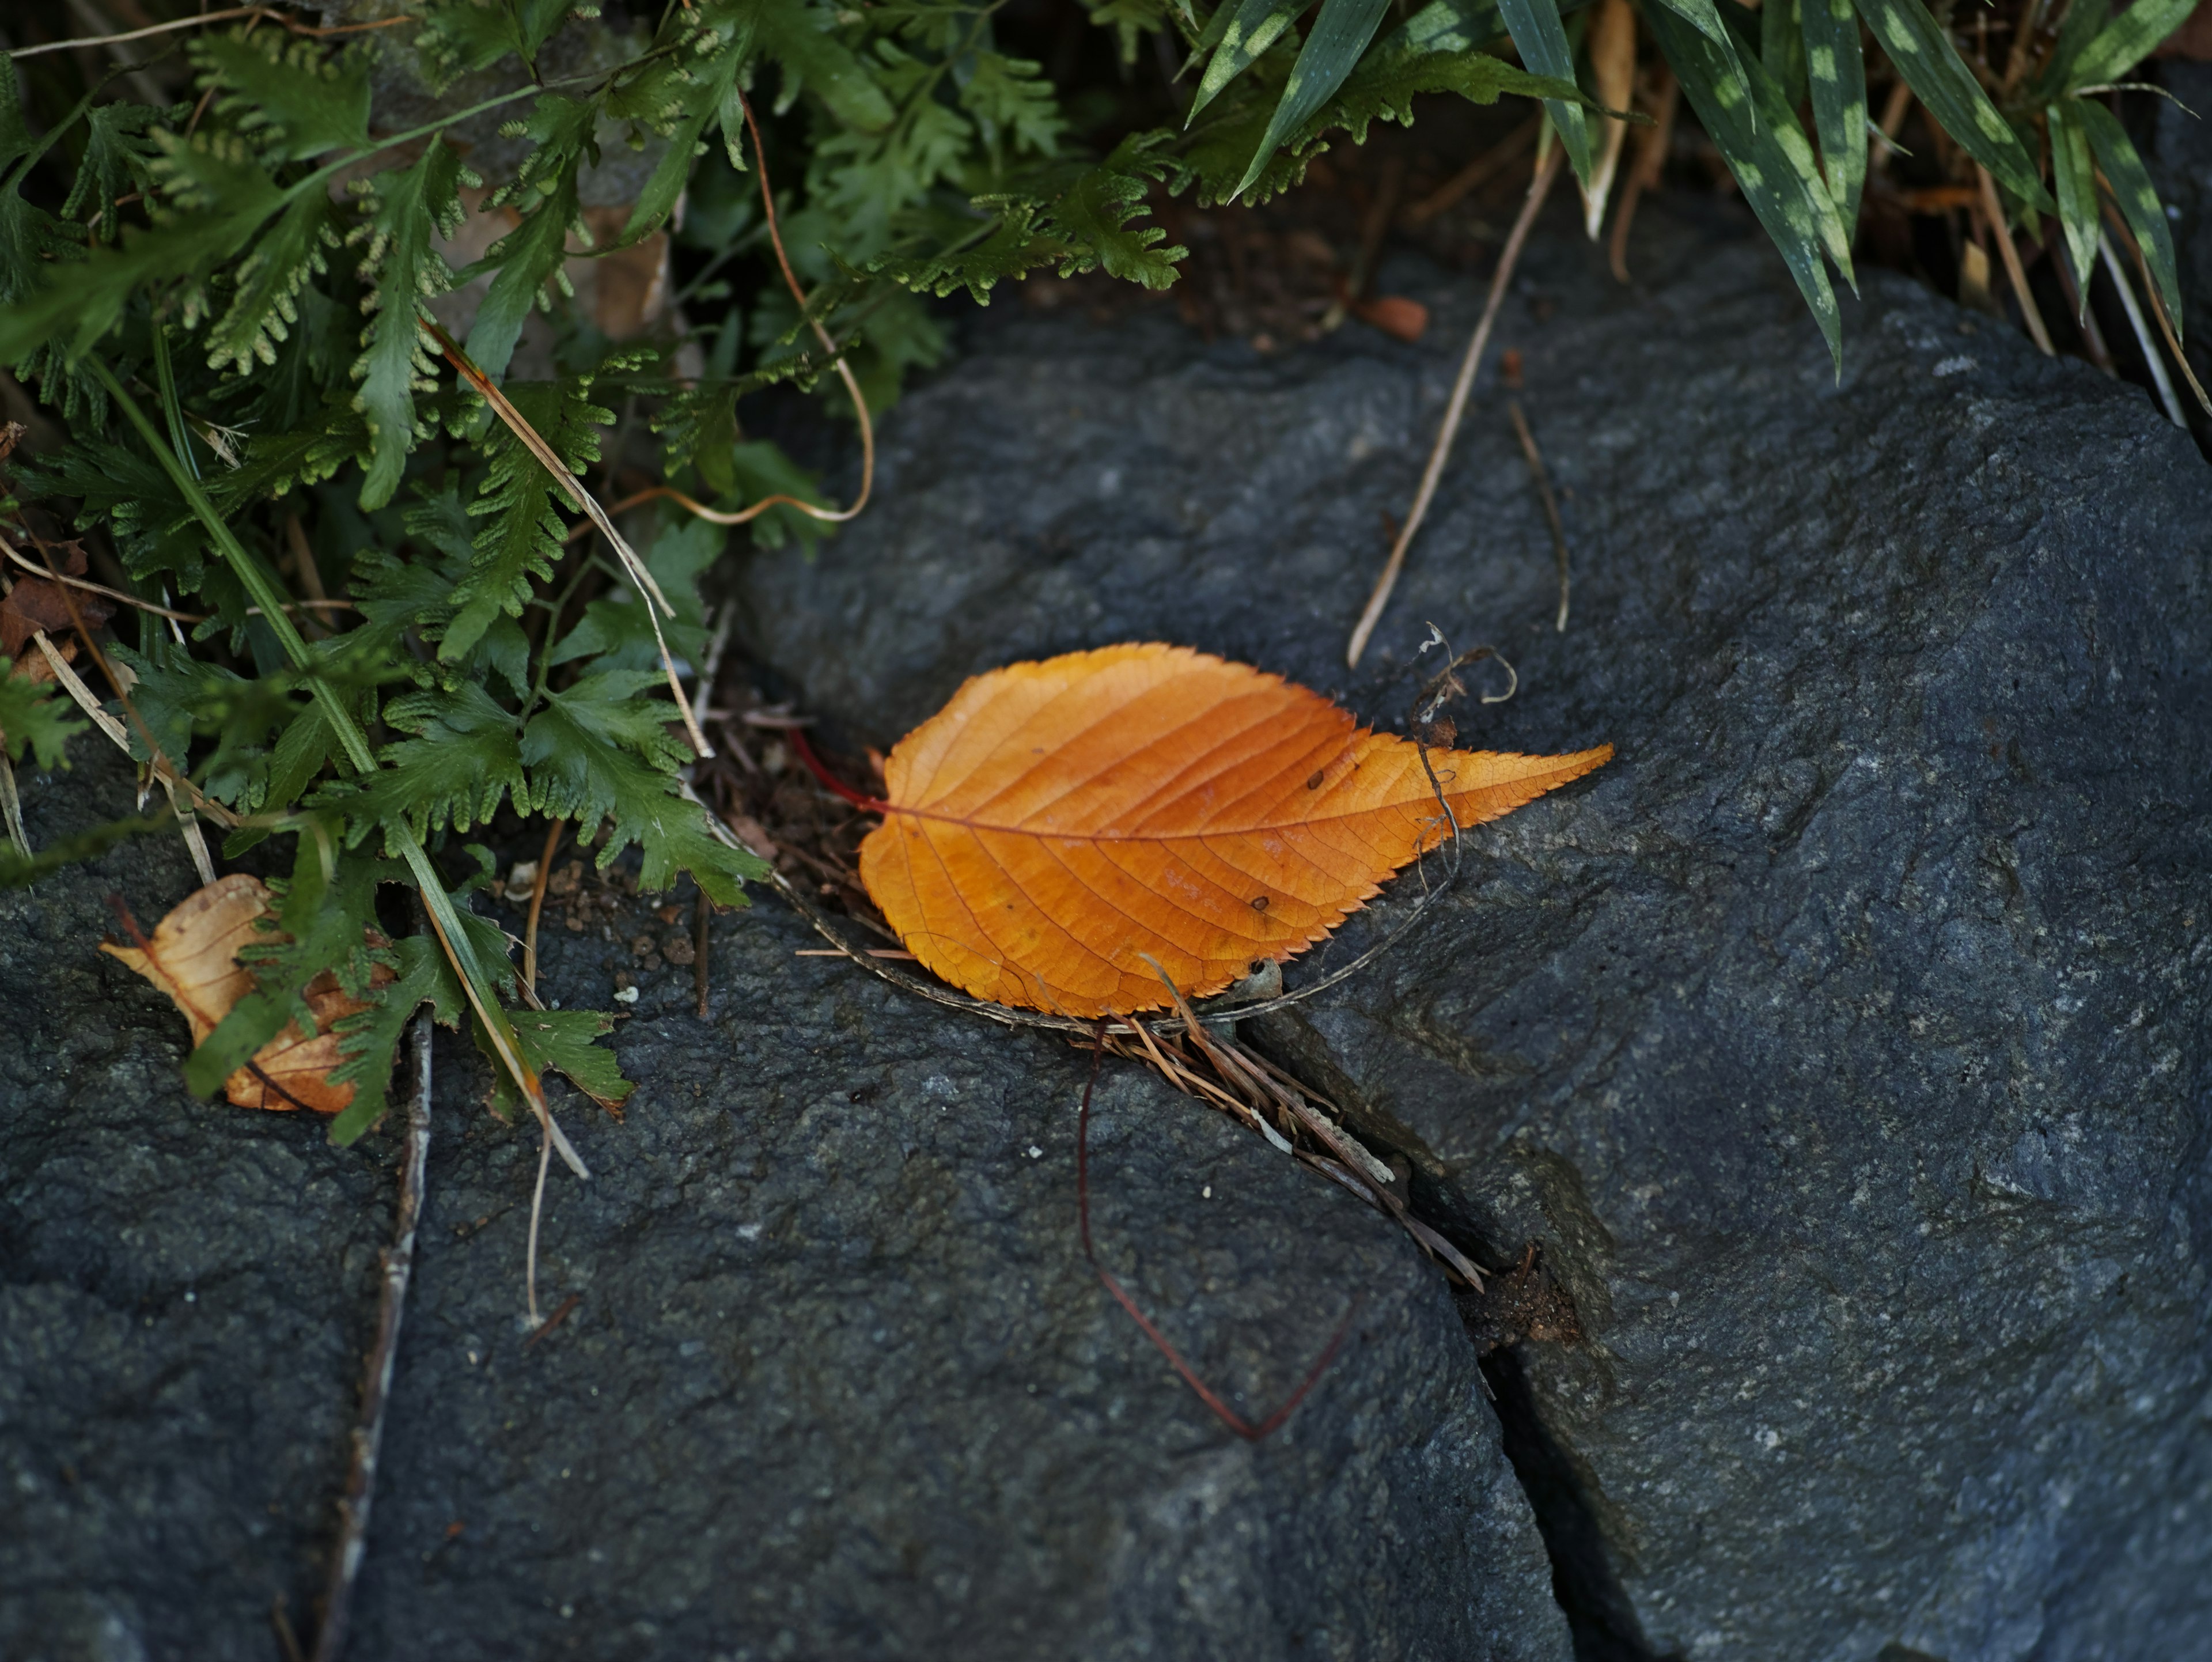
[84,356,590,1180]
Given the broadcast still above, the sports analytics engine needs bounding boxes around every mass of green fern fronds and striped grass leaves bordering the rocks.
[0,0,2190,1139]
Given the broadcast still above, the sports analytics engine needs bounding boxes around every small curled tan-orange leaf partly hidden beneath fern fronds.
[100,872,392,1113]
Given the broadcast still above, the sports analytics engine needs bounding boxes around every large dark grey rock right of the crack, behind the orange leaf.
[743,198,2212,1662]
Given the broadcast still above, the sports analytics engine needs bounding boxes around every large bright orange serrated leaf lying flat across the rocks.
[861,644,1612,1016]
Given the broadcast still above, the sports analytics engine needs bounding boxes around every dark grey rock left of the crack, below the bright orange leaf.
[0,755,1569,1662]
